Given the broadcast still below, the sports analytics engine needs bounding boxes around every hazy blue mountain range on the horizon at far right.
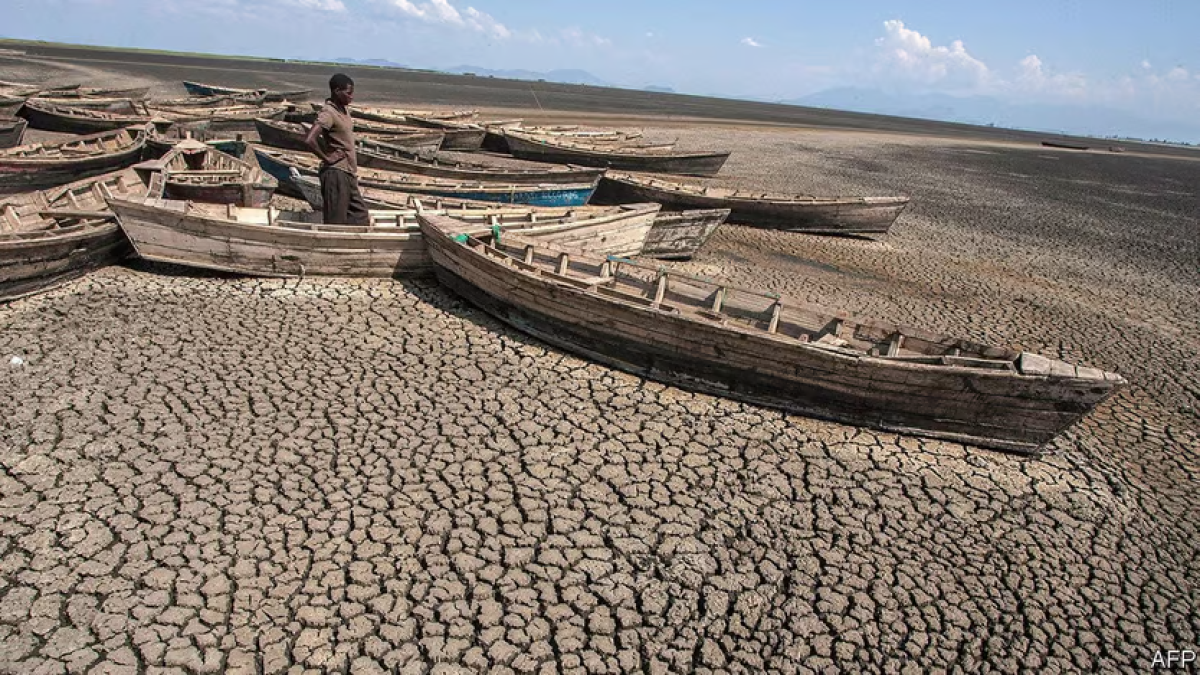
[779,86,1200,143]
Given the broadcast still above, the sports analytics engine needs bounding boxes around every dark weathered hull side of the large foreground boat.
[426,222,1111,453]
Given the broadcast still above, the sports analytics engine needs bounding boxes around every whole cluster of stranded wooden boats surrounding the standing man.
[0,77,1124,452]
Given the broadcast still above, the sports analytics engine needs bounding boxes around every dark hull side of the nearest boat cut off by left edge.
[0,223,132,303]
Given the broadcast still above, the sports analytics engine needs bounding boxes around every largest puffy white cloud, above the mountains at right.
[875,19,990,89]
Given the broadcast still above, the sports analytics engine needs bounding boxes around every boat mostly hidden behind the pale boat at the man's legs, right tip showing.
[292,168,730,261]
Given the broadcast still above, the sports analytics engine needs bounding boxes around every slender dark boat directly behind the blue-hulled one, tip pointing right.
[504,129,730,175]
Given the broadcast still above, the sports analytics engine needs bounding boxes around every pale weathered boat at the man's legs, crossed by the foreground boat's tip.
[109,197,659,276]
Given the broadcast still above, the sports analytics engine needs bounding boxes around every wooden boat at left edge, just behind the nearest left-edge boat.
[0,127,146,192]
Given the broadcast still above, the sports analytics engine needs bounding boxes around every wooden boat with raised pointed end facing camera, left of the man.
[145,138,278,207]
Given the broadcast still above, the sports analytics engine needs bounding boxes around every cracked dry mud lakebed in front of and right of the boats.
[0,129,1200,673]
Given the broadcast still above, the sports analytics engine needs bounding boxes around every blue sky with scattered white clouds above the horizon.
[7,0,1200,132]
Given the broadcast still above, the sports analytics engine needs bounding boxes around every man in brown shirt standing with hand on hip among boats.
[304,73,371,225]
